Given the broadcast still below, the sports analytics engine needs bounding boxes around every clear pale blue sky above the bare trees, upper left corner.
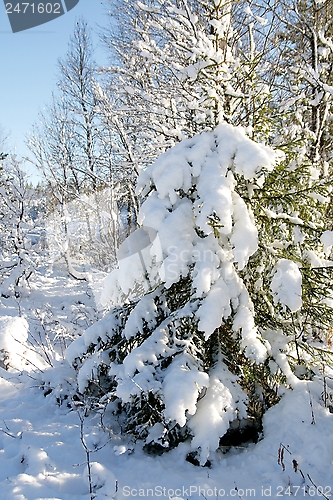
[0,0,109,182]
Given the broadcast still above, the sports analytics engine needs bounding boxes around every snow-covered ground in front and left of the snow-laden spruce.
[0,270,333,500]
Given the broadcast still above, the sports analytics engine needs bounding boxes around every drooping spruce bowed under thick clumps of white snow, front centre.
[67,124,275,464]
